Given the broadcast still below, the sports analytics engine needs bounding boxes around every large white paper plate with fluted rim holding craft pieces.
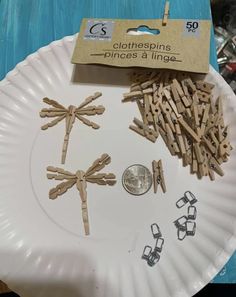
[0,36,236,297]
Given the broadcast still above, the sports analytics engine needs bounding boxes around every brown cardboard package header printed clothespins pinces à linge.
[72,19,211,73]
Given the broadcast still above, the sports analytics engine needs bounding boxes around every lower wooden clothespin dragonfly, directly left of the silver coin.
[47,154,116,235]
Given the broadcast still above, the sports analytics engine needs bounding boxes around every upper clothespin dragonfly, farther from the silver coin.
[40,92,105,164]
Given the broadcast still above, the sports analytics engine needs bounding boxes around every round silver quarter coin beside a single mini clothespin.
[122,164,152,196]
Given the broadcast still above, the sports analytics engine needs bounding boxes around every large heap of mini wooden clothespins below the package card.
[123,71,232,180]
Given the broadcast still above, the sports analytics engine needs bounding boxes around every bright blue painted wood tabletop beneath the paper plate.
[0,0,236,283]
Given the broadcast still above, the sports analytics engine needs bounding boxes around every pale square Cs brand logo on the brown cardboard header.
[84,20,114,41]
